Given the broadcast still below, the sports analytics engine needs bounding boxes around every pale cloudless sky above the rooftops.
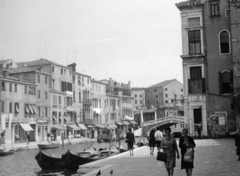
[0,0,183,87]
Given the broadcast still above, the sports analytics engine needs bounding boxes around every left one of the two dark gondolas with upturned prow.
[35,150,65,170]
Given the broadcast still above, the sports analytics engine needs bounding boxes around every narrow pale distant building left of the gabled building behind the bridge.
[131,87,145,111]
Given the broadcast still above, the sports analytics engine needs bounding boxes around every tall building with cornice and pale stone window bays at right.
[176,0,240,135]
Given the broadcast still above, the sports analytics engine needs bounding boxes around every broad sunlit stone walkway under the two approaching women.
[76,139,240,176]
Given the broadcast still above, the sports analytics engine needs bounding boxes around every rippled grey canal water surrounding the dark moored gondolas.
[0,140,131,176]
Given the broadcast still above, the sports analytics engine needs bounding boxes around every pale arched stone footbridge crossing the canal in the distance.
[142,116,185,136]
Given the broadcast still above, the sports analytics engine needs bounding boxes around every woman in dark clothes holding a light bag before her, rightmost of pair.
[179,129,196,176]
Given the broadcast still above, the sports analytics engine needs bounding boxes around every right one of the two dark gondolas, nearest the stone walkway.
[62,150,100,170]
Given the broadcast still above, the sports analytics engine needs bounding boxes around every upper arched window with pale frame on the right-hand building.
[219,31,230,54]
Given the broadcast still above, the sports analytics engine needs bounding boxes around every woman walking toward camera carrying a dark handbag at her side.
[160,127,179,176]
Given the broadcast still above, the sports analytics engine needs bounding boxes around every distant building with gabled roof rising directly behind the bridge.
[145,79,183,109]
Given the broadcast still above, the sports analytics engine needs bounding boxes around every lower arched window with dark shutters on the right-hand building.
[219,70,233,94]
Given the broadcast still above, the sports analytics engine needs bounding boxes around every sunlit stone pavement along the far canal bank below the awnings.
[2,138,97,150]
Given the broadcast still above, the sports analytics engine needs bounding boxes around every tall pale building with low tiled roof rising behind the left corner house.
[17,59,74,139]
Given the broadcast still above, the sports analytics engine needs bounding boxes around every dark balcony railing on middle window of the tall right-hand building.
[188,78,206,94]
